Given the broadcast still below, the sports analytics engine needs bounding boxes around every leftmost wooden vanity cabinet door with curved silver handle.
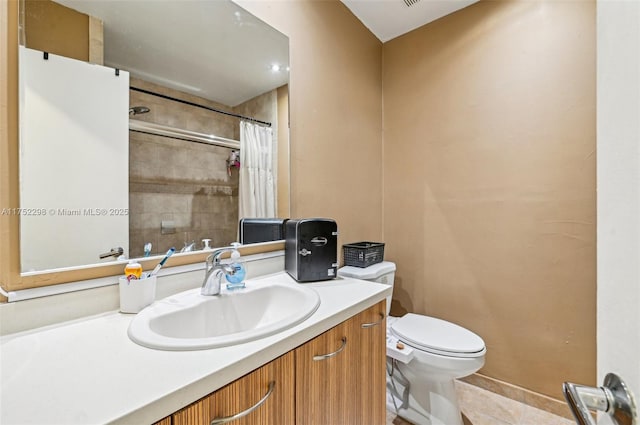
[173,352,295,425]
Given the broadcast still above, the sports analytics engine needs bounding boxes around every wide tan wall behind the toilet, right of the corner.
[383,1,596,398]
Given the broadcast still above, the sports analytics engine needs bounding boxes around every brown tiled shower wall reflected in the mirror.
[129,79,278,256]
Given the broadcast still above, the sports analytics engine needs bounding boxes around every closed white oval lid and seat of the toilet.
[391,313,485,357]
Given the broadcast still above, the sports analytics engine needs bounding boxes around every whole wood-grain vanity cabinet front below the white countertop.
[156,301,386,425]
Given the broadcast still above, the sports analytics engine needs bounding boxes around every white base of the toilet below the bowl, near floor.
[387,358,463,425]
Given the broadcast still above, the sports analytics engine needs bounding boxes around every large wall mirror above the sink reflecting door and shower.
[20,0,289,274]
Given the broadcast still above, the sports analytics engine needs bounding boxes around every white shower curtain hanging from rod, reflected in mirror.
[239,121,276,218]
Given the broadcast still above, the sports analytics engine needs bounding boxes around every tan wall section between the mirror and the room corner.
[237,0,382,252]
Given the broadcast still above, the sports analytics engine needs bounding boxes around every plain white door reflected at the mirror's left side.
[20,46,129,271]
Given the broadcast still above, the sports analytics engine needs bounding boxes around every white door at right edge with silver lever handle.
[597,0,640,424]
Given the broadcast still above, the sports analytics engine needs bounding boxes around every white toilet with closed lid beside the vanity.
[338,261,487,425]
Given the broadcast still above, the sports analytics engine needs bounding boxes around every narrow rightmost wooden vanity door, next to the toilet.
[350,301,387,425]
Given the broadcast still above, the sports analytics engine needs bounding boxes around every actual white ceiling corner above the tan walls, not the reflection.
[341,0,478,43]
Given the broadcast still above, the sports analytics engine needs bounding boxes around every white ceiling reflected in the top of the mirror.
[56,0,289,106]
